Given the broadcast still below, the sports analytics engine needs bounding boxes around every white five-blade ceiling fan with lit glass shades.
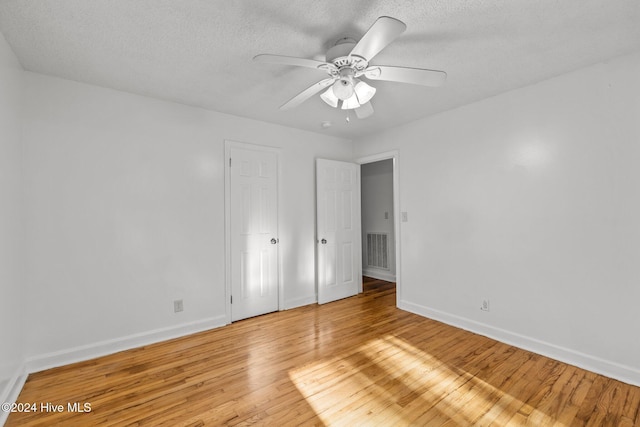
[253,16,447,119]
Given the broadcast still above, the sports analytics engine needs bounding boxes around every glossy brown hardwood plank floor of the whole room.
[7,279,640,426]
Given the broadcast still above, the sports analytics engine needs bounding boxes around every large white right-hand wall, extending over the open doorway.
[354,54,640,384]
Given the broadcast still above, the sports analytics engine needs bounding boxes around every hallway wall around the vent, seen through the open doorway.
[360,159,396,281]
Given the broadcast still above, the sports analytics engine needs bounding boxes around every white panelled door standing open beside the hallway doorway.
[316,159,362,304]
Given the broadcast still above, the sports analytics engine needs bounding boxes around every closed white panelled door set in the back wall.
[229,147,278,321]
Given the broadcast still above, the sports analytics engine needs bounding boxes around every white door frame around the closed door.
[224,139,284,324]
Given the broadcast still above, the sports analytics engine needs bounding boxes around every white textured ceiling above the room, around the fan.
[0,0,640,138]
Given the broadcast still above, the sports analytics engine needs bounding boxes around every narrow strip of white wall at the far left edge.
[0,30,25,408]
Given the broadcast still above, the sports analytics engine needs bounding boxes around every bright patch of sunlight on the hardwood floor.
[289,335,553,426]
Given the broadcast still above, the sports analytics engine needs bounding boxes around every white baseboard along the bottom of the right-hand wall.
[398,301,640,387]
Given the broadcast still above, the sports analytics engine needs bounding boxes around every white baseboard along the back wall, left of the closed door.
[25,315,227,373]
